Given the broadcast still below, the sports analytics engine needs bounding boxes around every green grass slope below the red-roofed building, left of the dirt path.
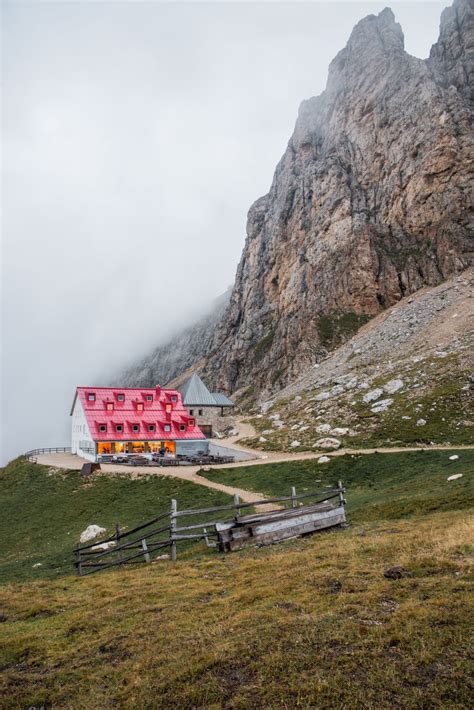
[0,459,235,582]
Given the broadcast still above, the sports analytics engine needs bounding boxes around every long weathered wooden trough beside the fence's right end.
[216,502,346,552]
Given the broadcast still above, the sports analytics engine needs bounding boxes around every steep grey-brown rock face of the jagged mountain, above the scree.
[124,0,474,392]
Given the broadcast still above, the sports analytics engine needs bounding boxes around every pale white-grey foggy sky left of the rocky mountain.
[1,1,445,463]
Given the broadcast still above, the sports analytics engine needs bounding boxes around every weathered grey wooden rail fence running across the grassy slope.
[74,481,346,576]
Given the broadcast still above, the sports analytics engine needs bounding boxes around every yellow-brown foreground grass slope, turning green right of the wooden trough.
[0,452,473,710]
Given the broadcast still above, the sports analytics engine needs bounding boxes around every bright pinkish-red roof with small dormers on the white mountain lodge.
[71,387,206,441]
